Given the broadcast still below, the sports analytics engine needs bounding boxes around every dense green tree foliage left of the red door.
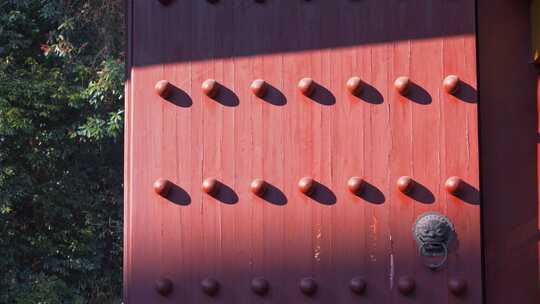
[0,0,124,303]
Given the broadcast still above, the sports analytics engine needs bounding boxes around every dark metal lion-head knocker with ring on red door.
[413,212,456,270]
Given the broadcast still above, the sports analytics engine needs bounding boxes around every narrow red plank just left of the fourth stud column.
[284,2,312,303]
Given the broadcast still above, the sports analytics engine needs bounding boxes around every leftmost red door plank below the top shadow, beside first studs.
[132,63,164,302]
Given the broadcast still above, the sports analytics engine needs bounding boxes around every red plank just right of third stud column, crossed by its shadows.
[260,1,288,303]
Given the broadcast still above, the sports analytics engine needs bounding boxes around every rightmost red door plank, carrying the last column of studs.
[441,1,482,303]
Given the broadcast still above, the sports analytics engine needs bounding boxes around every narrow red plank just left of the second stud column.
[192,1,213,303]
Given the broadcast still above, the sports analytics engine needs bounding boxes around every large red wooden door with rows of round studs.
[125,0,482,303]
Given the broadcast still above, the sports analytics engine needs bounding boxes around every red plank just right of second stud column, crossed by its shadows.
[213,2,240,303]
